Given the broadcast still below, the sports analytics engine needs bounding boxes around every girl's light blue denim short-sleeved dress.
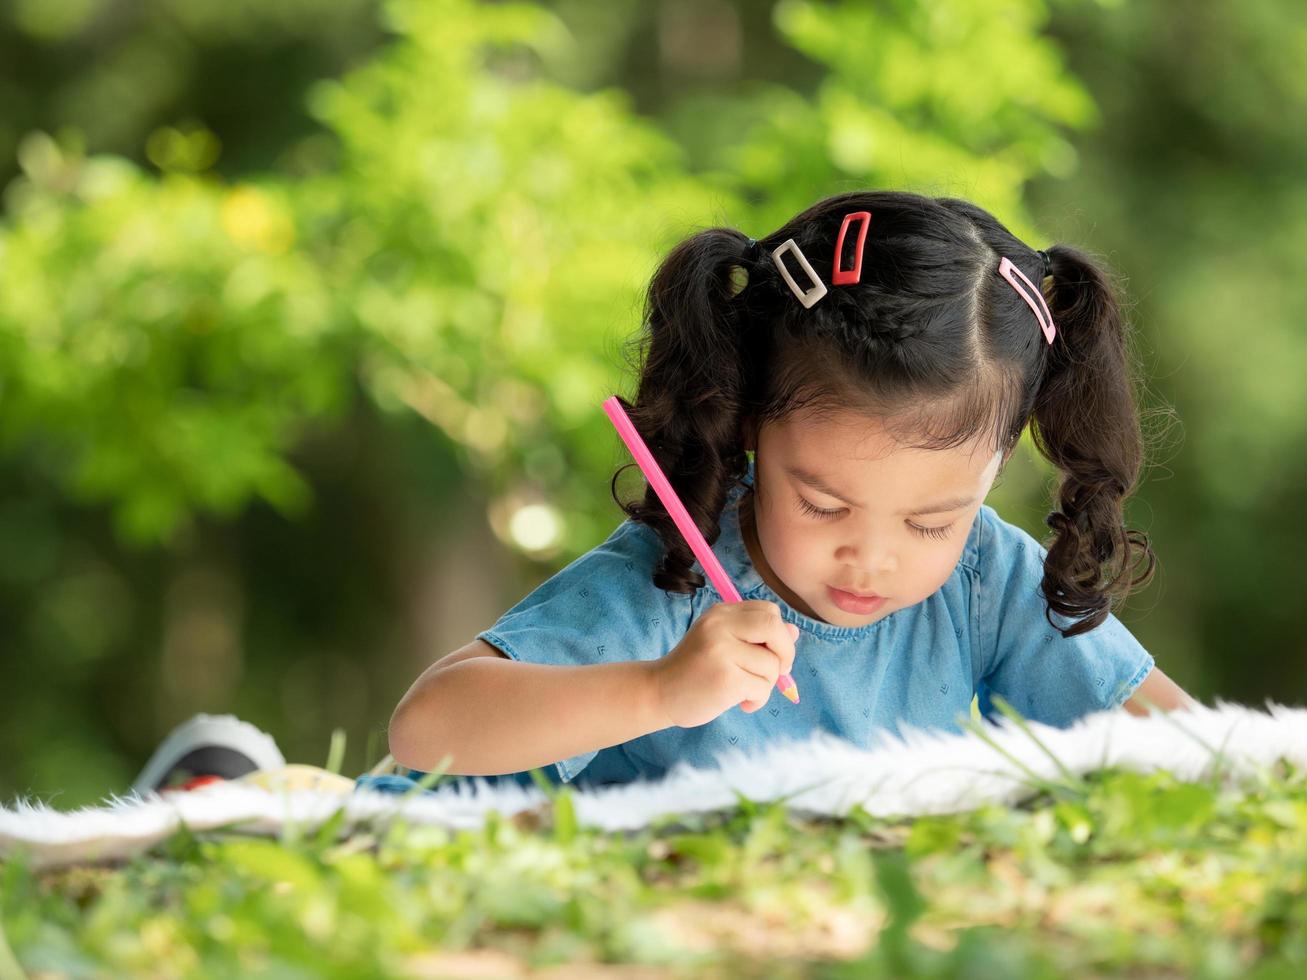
[359,463,1154,789]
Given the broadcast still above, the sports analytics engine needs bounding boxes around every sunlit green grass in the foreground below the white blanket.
[0,710,1307,980]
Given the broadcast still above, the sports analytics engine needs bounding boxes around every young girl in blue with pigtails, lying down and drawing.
[365,191,1192,785]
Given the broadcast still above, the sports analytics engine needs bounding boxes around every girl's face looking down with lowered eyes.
[740,416,1002,626]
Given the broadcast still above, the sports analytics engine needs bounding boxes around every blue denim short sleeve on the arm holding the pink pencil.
[477,520,693,783]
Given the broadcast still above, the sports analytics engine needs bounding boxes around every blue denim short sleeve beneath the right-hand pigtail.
[976,506,1154,728]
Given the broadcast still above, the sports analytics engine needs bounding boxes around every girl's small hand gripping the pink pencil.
[650,598,799,728]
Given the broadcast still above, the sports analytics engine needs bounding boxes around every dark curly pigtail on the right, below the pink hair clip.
[1030,246,1157,638]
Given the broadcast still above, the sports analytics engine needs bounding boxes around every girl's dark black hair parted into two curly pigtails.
[613,191,1157,636]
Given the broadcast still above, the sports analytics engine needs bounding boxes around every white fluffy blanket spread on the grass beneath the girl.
[0,699,1307,868]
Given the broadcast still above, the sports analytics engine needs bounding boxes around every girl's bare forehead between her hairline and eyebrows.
[758,416,1000,493]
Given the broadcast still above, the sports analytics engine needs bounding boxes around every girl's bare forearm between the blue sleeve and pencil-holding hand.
[389,640,668,776]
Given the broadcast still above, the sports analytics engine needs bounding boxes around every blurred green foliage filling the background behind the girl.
[0,0,1303,805]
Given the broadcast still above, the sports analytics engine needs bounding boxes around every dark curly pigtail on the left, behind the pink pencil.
[612,227,753,593]
